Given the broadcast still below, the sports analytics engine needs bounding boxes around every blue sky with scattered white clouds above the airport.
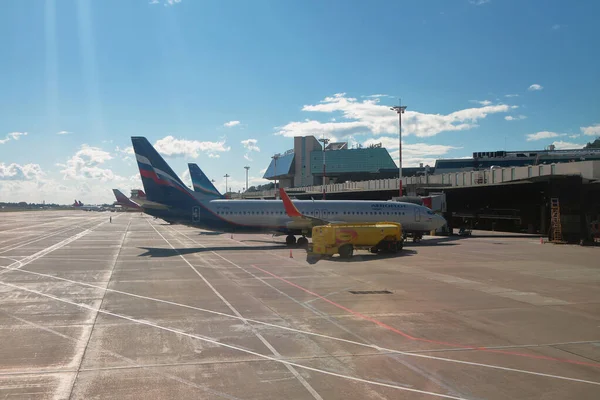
[0,0,600,204]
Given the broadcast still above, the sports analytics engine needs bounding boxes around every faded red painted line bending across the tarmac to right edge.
[252,265,600,368]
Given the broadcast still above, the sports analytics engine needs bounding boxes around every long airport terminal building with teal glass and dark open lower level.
[254,136,600,242]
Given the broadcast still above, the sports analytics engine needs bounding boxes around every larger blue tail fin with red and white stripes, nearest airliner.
[131,136,197,209]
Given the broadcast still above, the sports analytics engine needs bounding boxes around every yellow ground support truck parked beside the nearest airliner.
[308,222,404,258]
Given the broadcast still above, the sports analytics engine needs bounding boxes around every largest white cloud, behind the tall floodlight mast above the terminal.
[276,93,510,137]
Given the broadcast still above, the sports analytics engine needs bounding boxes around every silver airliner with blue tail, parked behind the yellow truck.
[131,136,446,246]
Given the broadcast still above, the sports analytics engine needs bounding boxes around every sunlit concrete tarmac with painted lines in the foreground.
[0,211,600,400]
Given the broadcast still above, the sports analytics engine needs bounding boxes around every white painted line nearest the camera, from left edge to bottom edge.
[0,281,468,400]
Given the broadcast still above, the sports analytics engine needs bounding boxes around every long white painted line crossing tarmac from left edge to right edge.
[0,260,600,386]
